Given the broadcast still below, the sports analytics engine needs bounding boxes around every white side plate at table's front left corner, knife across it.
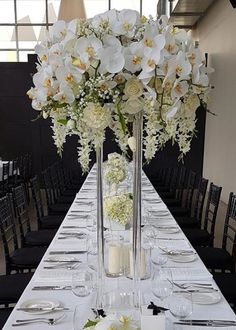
[20,299,61,314]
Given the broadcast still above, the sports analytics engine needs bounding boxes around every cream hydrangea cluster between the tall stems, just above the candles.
[104,193,133,225]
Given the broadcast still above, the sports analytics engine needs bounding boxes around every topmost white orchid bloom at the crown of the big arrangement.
[111,9,139,38]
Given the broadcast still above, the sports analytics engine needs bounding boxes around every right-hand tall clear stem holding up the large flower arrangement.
[133,112,143,307]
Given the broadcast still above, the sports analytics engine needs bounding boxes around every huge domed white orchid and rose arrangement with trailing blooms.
[28,9,212,171]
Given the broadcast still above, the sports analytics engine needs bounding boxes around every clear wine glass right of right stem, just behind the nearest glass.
[152,269,173,301]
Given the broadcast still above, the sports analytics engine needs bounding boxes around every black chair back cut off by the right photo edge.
[222,192,236,260]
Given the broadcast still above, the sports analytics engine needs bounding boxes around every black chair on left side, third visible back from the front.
[30,175,64,229]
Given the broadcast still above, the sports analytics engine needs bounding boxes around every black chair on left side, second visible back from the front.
[12,184,56,246]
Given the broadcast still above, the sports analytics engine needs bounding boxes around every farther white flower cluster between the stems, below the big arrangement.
[105,152,127,184]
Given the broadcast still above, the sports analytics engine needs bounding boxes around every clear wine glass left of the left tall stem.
[72,267,94,297]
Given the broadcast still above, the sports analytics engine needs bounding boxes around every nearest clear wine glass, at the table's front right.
[169,291,193,319]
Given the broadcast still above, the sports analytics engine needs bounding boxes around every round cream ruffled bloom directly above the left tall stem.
[83,102,111,130]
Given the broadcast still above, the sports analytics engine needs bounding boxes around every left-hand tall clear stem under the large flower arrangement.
[96,147,105,308]
